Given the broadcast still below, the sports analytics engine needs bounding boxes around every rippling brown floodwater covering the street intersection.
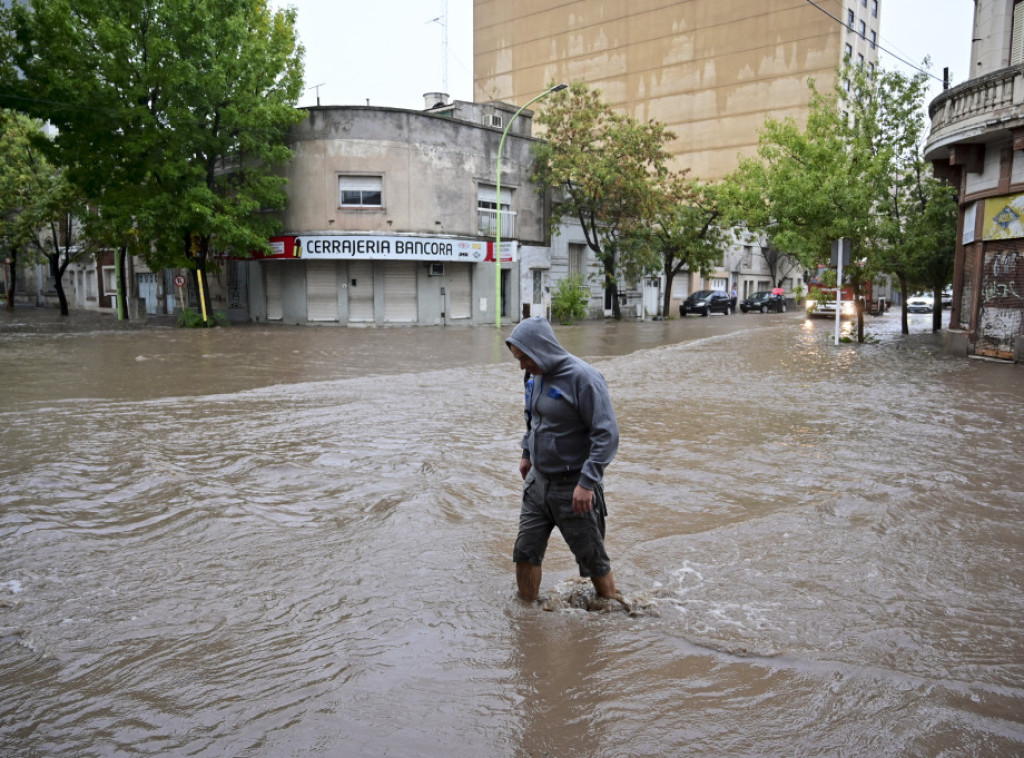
[0,312,1024,758]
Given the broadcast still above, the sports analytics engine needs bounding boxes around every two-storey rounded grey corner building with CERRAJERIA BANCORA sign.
[246,94,547,326]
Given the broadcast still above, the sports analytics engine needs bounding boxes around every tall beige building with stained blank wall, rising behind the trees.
[473,0,881,180]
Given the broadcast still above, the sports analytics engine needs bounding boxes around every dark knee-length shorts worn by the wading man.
[512,468,611,577]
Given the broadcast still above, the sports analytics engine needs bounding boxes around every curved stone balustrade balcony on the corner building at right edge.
[925,66,1024,154]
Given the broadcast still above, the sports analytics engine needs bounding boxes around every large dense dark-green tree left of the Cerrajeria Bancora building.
[2,0,302,323]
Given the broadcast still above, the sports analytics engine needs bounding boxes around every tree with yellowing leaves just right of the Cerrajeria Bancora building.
[534,82,674,319]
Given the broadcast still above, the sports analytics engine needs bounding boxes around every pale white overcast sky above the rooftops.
[282,0,974,110]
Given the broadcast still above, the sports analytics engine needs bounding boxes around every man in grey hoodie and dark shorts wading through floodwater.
[506,318,621,602]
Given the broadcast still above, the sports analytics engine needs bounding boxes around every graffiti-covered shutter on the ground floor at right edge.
[975,242,1024,361]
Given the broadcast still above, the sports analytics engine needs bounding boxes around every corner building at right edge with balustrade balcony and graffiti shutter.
[925,0,1024,362]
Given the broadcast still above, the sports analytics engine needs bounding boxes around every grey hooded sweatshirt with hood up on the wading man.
[506,317,618,490]
